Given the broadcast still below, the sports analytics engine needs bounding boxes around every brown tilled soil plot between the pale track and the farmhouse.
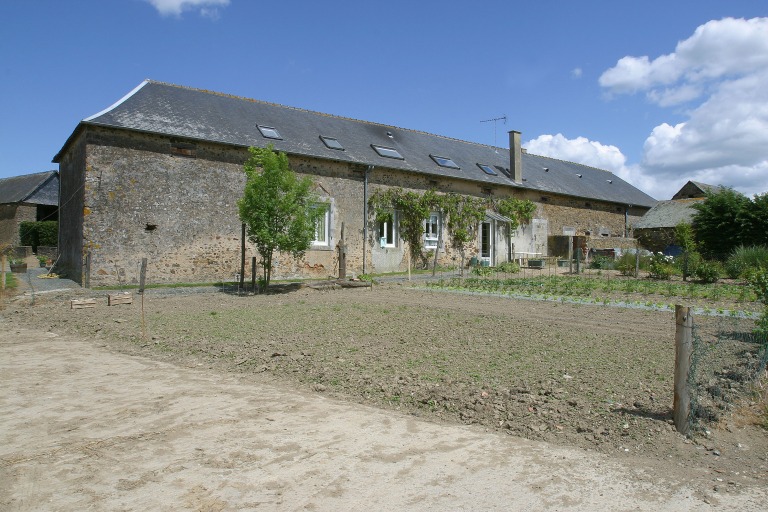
[3,284,768,492]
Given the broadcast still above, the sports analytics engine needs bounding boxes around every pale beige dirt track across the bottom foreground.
[0,324,768,511]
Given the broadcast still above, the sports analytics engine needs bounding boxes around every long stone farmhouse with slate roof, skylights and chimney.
[53,80,656,286]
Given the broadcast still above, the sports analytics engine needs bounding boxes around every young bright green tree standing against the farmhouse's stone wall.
[237,145,325,289]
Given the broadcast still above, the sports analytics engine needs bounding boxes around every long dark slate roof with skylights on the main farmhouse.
[53,80,656,207]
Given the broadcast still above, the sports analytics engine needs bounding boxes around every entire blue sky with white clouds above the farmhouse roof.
[0,0,768,199]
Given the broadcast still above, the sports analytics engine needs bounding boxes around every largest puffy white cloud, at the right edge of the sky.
[599,18,768,199]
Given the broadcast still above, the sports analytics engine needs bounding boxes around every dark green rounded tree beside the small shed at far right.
[692,188,753,258]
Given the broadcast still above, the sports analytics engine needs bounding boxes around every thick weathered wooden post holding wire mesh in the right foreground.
[673,304,693,434]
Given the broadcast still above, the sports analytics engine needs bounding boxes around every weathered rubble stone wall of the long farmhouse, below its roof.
[57,126,648,286]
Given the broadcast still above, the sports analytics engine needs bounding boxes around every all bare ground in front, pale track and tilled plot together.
[0,285,768,510]
